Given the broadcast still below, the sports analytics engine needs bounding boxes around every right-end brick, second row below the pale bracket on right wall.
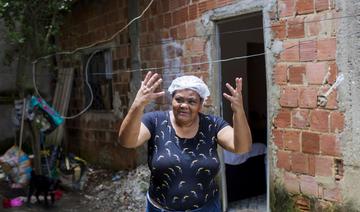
[320,134,341,156]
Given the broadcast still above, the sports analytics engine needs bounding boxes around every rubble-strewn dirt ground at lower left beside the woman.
[0,166,149,212]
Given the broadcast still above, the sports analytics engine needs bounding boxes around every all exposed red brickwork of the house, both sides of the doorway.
[60,0,345,206]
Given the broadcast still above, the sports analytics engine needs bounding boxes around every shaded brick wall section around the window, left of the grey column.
[60,0,136,169]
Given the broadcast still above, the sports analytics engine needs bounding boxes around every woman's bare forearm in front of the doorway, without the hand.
[233,110,252,153]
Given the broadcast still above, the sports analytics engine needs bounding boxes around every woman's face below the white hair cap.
[172,89,202,124]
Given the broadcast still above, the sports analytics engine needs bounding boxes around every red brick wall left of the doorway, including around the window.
[60,0,233,168]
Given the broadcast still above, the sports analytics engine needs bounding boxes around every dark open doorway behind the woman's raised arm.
[218,13,267,207]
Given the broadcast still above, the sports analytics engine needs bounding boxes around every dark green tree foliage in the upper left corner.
[0,0,74,60]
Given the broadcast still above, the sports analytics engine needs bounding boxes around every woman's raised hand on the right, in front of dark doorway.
[223,77,244,113]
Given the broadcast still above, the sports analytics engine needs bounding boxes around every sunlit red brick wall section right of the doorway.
[272,0,344,201]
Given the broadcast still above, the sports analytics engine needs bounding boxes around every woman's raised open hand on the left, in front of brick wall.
[134,71,165,107]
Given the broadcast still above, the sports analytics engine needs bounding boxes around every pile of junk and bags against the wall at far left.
[0,96,87,208]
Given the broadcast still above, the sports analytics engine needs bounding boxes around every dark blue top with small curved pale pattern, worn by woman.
[142,111,228,211]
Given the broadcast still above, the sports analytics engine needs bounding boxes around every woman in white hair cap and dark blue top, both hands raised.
[119,72,251,212]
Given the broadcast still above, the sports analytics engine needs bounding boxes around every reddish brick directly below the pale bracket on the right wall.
[310,110,330,132]
